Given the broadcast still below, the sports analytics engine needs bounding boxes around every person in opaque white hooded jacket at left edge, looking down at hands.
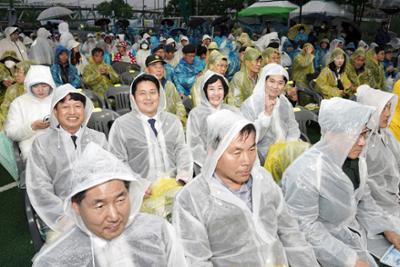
[5,65,56,160]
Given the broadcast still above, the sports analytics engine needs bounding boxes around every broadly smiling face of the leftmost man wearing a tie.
[54,95,85,134]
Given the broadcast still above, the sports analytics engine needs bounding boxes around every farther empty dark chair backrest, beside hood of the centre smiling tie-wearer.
[105,85,131,115]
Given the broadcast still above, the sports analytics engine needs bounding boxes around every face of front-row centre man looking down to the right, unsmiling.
[215,132,257,189]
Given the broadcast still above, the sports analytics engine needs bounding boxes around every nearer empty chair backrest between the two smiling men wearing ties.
[87,109,119,138]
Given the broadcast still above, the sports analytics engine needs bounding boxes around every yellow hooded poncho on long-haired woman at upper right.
[316,48,351,99]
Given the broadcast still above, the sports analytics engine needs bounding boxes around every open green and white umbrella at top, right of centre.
[238,1,299,18]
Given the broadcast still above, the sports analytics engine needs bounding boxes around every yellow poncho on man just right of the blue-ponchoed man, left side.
[82,58,120,97]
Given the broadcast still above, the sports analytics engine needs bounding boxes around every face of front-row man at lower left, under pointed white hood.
[72,180,131,240]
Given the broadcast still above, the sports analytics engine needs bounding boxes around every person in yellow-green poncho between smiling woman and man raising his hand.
[227,47,262,107]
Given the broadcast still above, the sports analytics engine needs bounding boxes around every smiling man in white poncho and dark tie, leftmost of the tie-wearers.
[26,84,108,239]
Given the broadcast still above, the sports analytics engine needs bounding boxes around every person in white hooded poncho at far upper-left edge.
[0,27,29,61]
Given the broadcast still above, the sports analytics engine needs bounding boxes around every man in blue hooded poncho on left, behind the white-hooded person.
[50,45,81,88]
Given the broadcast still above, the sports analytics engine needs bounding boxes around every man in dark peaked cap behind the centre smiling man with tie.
[146,55,186,125]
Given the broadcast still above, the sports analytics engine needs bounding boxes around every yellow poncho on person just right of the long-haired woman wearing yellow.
[346,48,371,88]
